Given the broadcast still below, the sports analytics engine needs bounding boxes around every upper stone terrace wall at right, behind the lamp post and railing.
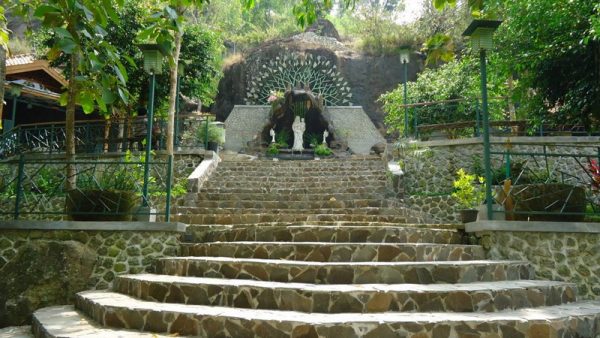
[391,137,600,222]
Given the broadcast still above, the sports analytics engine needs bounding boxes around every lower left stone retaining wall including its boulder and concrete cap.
[0,221,185,327]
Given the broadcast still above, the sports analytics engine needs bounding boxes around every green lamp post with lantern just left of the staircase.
[139,44,162,207]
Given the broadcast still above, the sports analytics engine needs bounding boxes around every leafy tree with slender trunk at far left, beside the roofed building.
[16,0,128,190]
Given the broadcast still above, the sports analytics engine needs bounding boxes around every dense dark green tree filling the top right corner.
[489,0,600,129]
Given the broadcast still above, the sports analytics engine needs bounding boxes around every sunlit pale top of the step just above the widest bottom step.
[115,273,577,293]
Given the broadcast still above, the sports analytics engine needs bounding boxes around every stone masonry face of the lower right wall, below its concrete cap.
[477,231,600,299]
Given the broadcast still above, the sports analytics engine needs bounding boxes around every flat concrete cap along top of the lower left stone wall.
[0,220,187,232]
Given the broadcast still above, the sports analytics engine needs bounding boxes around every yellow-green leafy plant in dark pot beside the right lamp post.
[452,168,485,223]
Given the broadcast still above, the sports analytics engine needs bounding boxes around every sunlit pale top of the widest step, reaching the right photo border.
[76,291,600,333]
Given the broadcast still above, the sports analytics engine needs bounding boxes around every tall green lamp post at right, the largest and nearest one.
[463,20,502,219]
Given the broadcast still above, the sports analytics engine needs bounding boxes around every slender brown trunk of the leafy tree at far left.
[65,51,79,191]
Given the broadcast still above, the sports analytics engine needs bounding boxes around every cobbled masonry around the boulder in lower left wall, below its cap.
[0,230,179,289]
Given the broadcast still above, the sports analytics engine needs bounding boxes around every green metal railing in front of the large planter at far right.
[487,145,600,221]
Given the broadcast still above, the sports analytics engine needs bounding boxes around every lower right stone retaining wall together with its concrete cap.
[466,221,600,299]
